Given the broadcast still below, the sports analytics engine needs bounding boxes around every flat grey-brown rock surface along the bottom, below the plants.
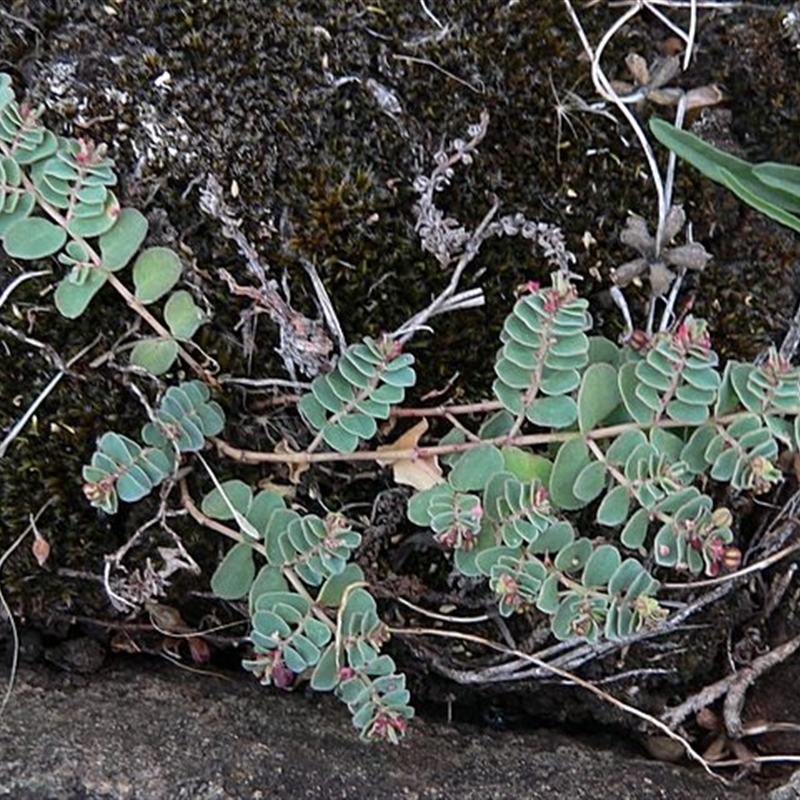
[0,662,758,800]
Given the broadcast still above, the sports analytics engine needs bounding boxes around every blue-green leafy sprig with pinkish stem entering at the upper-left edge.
[0,73,205,376]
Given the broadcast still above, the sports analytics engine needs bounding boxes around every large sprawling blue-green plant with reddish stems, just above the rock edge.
[79,273,800,741]
